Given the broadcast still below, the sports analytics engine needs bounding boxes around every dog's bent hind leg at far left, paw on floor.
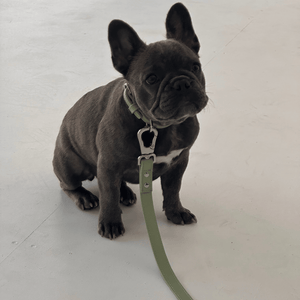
[53,149,99,210]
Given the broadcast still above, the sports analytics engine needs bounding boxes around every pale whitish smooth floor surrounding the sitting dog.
[0,0,300,300]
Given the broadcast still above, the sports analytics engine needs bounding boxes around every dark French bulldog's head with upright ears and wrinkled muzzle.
[108,3,208,126]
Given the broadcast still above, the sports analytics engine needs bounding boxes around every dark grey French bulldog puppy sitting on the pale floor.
[53,3,208,239]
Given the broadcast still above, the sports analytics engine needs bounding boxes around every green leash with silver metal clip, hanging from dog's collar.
[138,123,193,300]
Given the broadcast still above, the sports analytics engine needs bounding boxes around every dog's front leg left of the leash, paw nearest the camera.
[97,162,125,239]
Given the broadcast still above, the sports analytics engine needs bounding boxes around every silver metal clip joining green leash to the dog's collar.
[137,122,158,165]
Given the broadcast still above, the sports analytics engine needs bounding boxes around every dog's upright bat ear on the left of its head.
[108,20,146,76]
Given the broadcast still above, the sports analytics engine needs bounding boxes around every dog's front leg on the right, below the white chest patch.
[161,150,197,225]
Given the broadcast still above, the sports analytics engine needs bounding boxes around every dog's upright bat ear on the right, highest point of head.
[166,3,200,53]
